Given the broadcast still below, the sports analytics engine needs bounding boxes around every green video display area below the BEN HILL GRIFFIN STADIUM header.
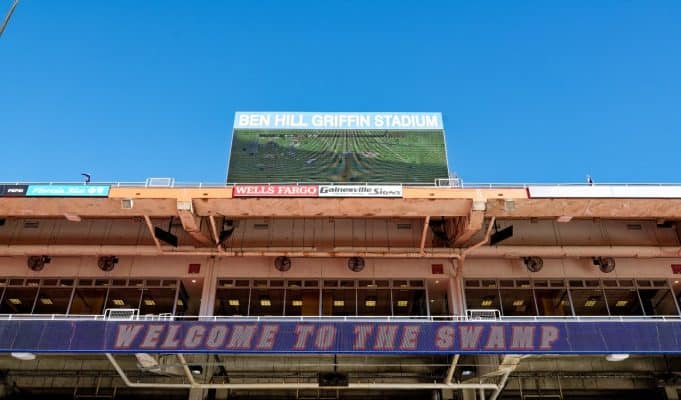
[227,129,448,183]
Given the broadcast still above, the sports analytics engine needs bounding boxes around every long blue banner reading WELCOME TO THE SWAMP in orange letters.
[0,320,681,354]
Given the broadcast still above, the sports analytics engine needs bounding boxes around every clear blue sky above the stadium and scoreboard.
[0,0,681,182]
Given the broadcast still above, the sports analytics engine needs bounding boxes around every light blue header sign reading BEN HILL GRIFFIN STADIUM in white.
[234,112,443,130]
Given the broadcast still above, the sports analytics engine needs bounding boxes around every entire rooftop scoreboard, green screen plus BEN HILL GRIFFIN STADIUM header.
[227,112,448,184]
